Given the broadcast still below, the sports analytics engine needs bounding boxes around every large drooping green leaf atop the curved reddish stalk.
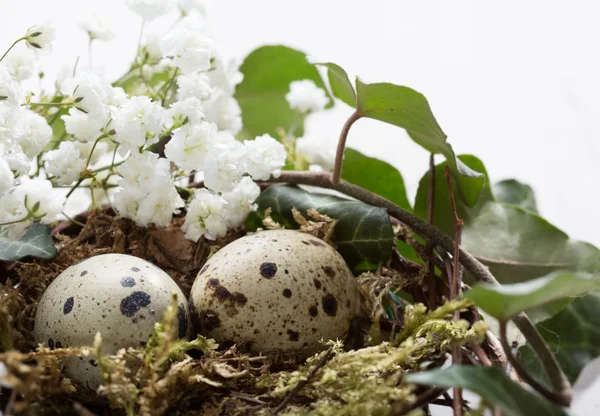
[356,78,482,183]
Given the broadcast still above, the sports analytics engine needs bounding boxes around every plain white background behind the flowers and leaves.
[0,0,600,414]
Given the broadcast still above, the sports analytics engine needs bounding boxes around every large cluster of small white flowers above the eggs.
[0,0,288,241]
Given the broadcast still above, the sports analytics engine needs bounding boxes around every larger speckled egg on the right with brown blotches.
[190,230,360,358]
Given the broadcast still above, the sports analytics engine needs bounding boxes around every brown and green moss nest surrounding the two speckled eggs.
[0,210,485,415]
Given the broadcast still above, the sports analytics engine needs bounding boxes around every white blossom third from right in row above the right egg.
[165,122,218,170]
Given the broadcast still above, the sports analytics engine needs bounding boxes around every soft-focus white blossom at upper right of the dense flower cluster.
[161,27,214,74]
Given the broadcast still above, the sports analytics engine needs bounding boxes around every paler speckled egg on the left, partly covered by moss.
[34,254,191,391]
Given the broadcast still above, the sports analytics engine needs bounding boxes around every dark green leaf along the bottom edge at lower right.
[402,365,568,416]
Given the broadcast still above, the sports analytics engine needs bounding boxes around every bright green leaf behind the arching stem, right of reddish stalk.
[342,148,412,211]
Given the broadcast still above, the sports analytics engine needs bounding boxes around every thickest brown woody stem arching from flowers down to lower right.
[254,171,571,394]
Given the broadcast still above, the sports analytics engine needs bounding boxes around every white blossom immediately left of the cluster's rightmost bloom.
[204,141,245,192]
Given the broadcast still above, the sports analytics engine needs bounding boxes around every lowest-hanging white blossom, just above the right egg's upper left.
[181,188,227,242]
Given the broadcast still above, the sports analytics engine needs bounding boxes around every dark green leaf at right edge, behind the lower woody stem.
[519,293,600,384]
